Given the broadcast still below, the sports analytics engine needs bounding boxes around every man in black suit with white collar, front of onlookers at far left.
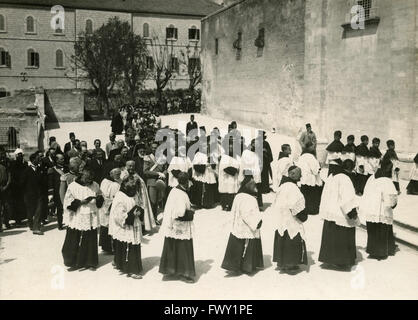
[22,152,44,235]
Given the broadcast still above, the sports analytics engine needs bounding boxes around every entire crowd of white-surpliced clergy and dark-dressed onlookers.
[0,110,418,282]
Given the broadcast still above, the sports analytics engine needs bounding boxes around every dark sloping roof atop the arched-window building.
[0,0,222,17]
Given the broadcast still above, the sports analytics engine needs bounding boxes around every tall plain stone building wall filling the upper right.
[202,0,418,153]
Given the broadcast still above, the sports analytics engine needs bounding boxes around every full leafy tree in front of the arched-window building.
[71,17,147,116]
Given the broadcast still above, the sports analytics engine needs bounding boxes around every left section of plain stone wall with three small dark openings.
[202,0,305,134]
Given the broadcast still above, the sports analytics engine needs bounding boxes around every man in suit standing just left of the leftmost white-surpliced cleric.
[48,154,68,230]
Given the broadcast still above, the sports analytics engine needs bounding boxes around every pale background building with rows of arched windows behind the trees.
[0,0,220,98]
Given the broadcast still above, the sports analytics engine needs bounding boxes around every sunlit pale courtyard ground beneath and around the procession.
[0,115,418,300]
